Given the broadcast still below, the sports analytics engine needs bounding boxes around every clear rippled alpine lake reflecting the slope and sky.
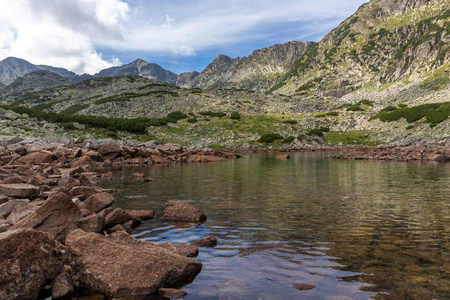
[97,152,450,300]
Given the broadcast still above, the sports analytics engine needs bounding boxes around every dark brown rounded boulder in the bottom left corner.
[0,230,63,300]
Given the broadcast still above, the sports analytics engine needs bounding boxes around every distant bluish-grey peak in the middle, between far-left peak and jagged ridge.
[94,59,178,84]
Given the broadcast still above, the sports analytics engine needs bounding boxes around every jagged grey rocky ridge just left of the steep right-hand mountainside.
[177,42,314,90]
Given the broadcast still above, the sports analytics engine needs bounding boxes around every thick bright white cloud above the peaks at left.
[0,0,128,73]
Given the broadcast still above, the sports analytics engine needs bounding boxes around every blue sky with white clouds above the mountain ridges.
[0,0,368,74]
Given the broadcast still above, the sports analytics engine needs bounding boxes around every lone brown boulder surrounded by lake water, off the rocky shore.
[162,200,206,222]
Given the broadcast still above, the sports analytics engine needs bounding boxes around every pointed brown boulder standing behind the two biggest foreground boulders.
[11,193,81,243]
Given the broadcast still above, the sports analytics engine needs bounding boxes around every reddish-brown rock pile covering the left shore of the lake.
[0,144,219,300]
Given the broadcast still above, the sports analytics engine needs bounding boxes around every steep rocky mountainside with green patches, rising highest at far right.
[270,0,450,98]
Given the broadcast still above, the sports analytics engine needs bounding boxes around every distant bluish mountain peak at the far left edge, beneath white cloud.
[2,70,71,94]
